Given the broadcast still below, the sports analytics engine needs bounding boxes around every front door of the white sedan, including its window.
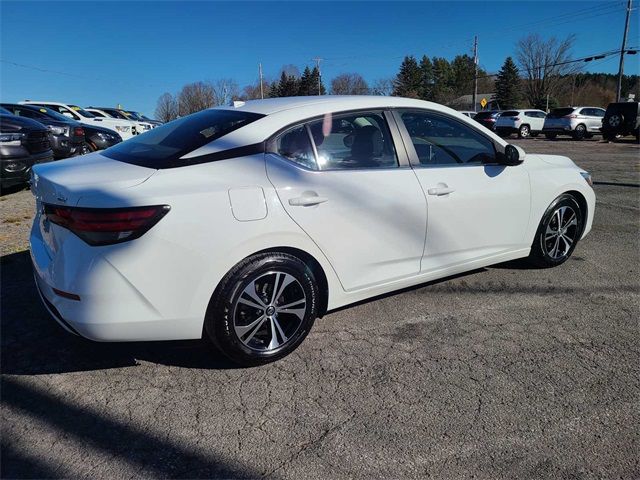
[396,110,530,273]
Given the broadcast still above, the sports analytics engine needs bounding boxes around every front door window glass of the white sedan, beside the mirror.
[400,111,496,166]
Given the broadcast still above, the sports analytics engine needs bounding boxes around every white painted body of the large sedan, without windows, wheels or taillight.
[31,97,595,341]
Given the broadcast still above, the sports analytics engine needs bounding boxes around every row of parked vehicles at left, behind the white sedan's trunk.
[0,100,161,189]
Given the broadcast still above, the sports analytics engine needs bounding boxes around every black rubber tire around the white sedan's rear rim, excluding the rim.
[205,254,319,366]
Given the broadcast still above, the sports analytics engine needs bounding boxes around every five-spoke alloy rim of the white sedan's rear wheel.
[233,271,307,352]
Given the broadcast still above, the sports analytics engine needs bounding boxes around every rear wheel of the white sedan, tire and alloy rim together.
[205,252,319,366]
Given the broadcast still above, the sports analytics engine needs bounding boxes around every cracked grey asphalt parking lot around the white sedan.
[0,138,640,479]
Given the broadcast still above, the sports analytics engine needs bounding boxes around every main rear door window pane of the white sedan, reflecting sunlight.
[309,111,398,170]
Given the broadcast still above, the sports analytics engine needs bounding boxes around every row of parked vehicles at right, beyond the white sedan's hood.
[460,102,640,140]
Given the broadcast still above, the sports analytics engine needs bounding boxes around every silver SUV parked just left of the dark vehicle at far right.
[542,107,605,140]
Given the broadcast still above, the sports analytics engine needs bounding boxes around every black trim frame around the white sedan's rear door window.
[265,107,411,172]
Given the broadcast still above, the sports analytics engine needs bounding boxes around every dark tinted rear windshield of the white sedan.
[102,110,264,168]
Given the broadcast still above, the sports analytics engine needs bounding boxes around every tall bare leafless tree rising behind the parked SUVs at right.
[516,34,580,109]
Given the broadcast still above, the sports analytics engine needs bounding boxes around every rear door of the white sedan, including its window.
[266,110,427,290]
